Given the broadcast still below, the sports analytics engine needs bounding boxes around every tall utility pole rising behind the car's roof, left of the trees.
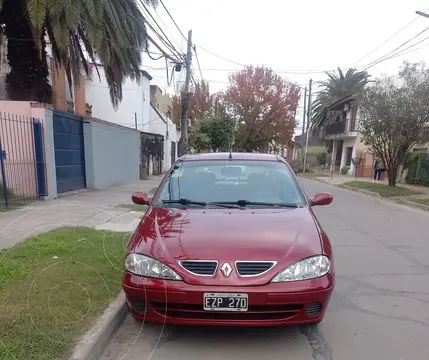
[179,30,192,156]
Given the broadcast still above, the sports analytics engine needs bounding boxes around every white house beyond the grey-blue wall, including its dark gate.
[85,67,180,175]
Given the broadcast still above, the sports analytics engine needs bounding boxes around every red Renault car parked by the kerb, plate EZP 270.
[123,153,335,326]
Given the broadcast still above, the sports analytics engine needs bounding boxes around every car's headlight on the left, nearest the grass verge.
[125,253,182,280]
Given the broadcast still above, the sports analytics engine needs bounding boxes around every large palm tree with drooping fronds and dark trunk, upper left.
[0,0,158,106]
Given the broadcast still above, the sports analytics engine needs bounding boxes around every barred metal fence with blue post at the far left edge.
[0,113,47,210]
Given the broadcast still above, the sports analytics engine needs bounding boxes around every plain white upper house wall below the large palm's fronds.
[85,68,150,131]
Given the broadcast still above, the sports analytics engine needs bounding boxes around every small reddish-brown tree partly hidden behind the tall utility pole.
[172,80,213,125]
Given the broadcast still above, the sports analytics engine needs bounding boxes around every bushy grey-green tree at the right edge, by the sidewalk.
[359,62,429,186]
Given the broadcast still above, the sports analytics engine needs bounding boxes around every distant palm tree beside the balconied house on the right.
[311,68,370,133]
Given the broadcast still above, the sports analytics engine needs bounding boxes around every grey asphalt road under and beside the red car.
[101,180,429,360]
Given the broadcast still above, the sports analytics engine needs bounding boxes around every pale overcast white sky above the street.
[138,0,429,135]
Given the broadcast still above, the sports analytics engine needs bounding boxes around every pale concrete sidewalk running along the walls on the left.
[0,176,162,249]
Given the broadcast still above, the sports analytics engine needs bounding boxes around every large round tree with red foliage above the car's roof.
[223,66,300,151]
